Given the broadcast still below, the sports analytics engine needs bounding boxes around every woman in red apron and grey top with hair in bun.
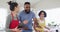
[6,1,21,32]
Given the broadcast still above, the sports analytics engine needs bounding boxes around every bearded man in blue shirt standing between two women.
[19,2,36,32]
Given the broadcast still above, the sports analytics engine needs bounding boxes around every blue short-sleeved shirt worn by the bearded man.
[19,11,35,29]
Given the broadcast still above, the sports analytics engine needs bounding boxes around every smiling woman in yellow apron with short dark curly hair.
[35,10,49,32]
